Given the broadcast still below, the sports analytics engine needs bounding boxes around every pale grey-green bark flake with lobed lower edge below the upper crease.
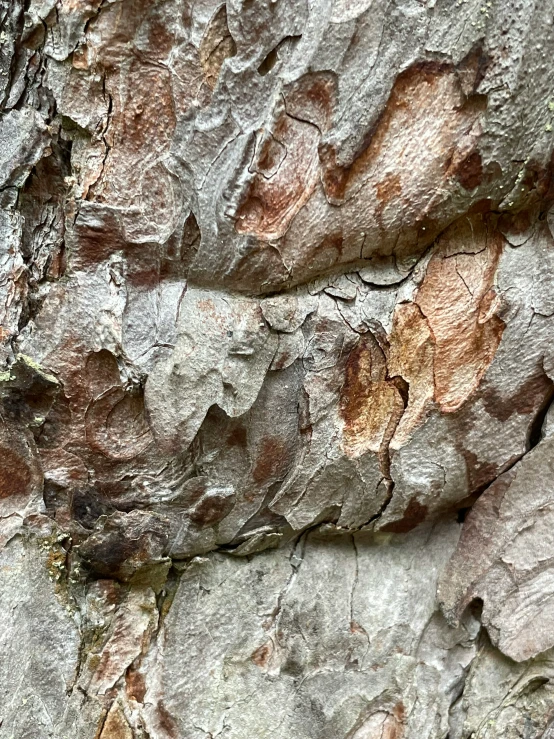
[146,289,277,448]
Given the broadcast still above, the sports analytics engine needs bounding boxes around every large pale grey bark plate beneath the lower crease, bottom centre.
[141,523,466,739]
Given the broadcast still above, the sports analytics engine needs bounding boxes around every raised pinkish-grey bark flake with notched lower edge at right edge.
[441,439,554,661]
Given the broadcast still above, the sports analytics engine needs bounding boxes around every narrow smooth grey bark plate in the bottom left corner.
[0,532,80,739]
